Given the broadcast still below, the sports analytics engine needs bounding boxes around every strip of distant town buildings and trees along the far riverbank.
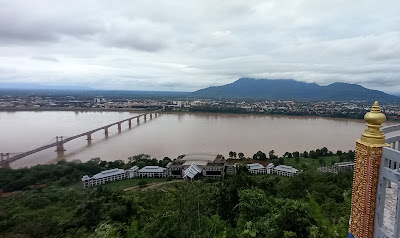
[0,80,400,121]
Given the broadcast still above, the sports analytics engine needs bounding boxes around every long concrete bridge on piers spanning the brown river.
[0,109,164,167]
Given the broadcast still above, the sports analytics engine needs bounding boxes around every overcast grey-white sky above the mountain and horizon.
[0,0,400,93]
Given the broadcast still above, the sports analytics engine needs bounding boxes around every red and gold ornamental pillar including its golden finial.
[348,102,389,238]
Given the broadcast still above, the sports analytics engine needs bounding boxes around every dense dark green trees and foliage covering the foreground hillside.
[0,155,352,238]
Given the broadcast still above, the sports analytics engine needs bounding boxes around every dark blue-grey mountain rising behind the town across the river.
[192,78,400,103]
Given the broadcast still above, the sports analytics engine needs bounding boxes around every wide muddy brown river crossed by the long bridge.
[0,111,392,168]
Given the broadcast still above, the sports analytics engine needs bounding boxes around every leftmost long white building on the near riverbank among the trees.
[82,169,127,188]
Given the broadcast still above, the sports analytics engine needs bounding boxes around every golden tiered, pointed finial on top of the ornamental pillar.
[361,101,386,146]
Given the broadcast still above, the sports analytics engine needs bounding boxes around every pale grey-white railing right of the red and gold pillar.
[374,125,400,238]
